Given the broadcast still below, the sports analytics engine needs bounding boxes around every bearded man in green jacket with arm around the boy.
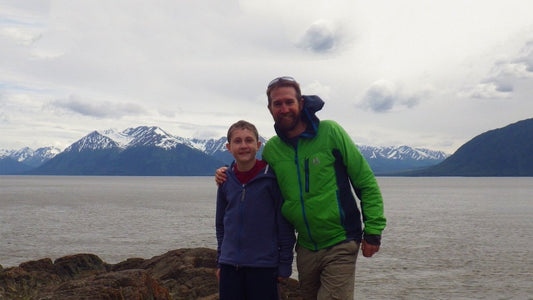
[217,76,386,299]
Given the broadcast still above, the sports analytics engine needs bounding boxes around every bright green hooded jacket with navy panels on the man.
[263,96,386,250]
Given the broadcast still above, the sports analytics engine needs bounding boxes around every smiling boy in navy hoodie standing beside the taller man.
[216,120,295,300]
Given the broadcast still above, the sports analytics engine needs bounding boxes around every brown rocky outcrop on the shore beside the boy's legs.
[0,248,301,300]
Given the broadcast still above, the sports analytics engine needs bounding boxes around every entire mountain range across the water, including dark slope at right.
[6,119,533,176]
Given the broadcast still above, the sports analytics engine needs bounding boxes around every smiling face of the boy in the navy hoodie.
[226,128,261,163]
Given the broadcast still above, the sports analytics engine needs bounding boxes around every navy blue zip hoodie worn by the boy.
[216,164,295,278]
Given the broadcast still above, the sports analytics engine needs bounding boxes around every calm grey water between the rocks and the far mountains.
[0,176,533,299]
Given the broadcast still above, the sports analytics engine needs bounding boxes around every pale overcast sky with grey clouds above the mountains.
[0,0,533,153]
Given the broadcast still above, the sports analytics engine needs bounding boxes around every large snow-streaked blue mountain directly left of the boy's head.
[28,126,228,176]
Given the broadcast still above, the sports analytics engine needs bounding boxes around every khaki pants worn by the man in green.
[296,241,359,300]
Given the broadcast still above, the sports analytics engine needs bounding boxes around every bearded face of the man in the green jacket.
[268,87,305,137]
